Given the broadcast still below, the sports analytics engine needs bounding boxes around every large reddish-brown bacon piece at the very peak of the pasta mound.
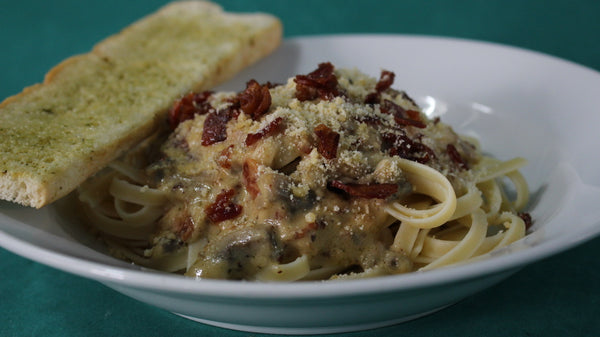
[294,62,340,101]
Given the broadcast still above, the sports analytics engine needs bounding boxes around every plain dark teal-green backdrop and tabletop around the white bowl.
[0,0,600,336]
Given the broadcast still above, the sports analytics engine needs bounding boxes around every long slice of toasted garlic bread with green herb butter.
[0,1,282,208]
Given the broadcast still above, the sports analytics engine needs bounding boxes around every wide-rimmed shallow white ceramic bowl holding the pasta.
[0,35,600,333]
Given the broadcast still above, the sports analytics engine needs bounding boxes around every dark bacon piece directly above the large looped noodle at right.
[381,133,435,164]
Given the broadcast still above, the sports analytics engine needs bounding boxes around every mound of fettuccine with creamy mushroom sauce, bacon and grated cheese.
[79,63,531,282]
